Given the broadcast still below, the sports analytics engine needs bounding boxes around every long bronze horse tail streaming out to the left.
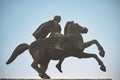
[6,43,29,64]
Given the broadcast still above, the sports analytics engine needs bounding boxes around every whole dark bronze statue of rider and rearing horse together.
[6,15,106,79]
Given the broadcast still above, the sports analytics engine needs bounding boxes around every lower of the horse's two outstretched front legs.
[79,52,106,72]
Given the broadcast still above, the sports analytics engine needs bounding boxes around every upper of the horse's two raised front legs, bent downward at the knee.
[82,39,105,57]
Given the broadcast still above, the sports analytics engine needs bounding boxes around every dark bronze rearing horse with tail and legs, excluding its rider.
[6,16,106,79]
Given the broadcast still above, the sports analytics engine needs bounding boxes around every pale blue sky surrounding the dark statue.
[0,0,120,80]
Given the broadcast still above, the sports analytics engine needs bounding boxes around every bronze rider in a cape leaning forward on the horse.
[33,16,63,50]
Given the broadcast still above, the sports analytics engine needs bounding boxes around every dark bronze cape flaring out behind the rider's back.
[33,20,54,39]
